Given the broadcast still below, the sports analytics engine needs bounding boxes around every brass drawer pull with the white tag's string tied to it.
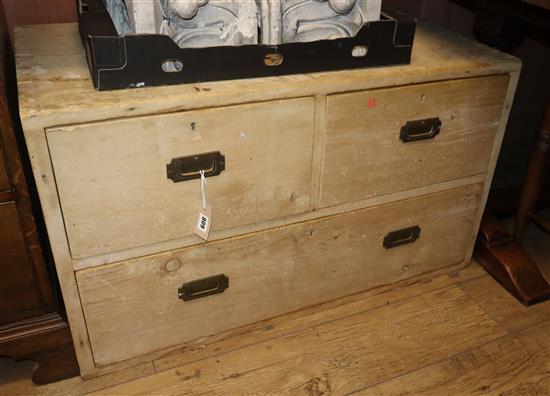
[166,151,225,183]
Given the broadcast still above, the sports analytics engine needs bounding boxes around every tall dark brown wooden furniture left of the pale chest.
[0,1,79,384]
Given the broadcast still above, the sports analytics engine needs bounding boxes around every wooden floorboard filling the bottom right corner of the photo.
[355,322,550,396]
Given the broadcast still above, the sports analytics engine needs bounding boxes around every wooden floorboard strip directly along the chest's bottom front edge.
[0,265,486,395]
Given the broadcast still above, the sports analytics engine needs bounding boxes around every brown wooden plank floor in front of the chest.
[0,220,550,396]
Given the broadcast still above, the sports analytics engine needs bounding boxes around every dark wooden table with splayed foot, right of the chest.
[455,0,550,305]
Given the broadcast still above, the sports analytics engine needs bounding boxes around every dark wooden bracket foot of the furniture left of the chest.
[0,313,79,385]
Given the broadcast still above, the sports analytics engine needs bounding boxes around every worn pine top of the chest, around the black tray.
[15,23,521,133]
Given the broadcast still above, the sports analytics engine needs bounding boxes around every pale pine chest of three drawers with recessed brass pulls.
[16,24,520,376]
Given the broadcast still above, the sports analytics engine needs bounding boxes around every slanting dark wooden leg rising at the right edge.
[514,104,550,242]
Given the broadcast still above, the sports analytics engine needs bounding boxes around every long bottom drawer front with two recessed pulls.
[77,185,481,365]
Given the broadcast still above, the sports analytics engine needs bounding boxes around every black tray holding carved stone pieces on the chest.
[78,0,416,90]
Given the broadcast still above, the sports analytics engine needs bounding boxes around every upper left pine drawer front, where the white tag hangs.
[47,98,314,258]
